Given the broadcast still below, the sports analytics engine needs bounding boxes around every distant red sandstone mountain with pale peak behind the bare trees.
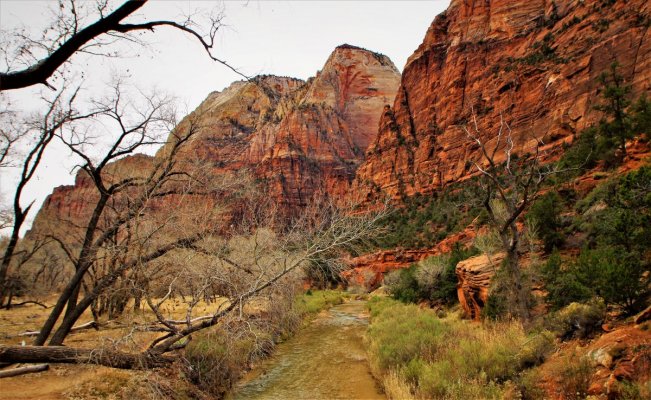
[34,45,400,233]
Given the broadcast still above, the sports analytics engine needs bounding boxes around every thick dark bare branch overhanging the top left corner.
[0,0,246,91]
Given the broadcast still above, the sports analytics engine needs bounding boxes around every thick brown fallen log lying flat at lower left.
[0,345,174,369]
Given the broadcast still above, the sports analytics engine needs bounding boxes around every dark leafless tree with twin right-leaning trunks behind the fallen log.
[29,83,197,345]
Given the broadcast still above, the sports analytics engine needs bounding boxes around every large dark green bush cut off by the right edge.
[577,167,651,313]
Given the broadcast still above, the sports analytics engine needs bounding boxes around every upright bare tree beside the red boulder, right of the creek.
[463,112,559,321]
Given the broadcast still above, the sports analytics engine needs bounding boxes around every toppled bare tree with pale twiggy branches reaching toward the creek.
[0,188,383,368]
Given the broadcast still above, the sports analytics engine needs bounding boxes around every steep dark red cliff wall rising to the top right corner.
[351,0,651,201]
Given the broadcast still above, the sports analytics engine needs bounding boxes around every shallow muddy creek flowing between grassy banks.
[228,300,385,400]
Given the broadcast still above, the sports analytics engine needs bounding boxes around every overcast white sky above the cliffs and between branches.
[0,0,449,233]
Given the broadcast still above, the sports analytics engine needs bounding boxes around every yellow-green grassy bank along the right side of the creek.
[368,297,554,399]
